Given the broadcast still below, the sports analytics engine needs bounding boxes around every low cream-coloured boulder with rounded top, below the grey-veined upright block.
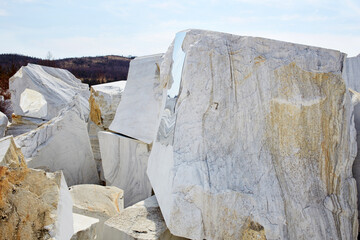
[70,184,124,239]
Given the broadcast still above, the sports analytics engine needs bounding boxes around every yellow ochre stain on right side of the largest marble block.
[266,63,346,194]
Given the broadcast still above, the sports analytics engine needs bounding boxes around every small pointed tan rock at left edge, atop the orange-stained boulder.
[0,136,26,167]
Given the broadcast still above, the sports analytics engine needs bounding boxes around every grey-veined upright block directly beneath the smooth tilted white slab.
[98,131,152,207]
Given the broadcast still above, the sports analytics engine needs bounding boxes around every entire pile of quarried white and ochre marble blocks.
[0,30,360,240]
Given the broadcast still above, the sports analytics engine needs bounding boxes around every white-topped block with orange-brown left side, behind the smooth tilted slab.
[88,81,126,181]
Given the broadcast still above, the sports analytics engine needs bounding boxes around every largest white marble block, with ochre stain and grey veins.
[147,30,358,239]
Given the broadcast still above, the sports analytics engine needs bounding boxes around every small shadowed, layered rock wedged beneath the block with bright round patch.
[5,114,48,137]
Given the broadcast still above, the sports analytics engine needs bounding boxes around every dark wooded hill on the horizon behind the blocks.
[0,54,132,98]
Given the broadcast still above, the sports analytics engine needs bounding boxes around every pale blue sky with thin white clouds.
[0,0,360,59]
